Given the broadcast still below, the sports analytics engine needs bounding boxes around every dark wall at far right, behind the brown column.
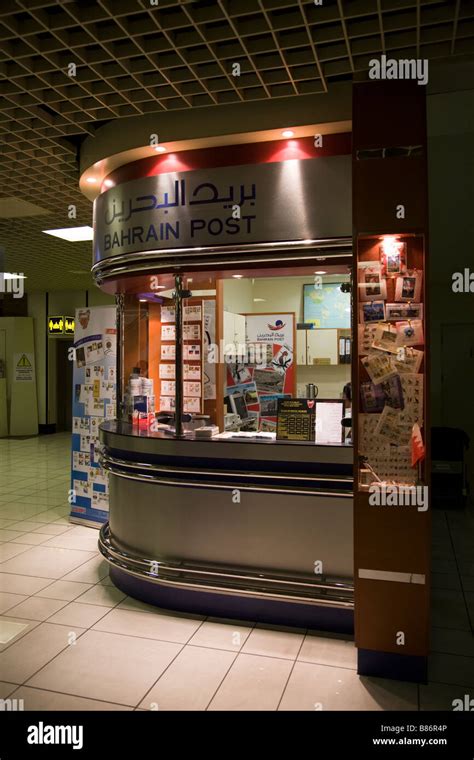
[427,63,474,480]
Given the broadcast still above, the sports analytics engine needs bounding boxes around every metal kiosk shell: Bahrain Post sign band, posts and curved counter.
[92,136,353,632]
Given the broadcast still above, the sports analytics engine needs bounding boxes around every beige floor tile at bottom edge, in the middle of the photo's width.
[208,654,293,710]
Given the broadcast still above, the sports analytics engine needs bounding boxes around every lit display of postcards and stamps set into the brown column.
[356,235,426,488]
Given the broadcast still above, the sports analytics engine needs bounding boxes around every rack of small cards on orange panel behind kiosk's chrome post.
[157,302,204,414]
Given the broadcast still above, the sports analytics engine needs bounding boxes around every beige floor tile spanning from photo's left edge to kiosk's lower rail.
[1,544,94,579]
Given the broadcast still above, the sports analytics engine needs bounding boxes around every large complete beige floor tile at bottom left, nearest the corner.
[27,631,181,707]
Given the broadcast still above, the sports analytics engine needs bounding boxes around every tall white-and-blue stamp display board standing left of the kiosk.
[70,306,117,527]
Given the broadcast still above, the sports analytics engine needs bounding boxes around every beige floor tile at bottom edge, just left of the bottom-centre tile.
[140,646,236,710]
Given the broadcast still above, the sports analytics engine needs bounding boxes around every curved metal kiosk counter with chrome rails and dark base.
[99,421,353,631]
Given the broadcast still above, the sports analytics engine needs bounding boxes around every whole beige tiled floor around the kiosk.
[0,434,474,710]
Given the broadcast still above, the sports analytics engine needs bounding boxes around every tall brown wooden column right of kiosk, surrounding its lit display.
[352,81,431,681]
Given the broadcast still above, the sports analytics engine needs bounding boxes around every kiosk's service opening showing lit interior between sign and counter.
[117,268,352,444]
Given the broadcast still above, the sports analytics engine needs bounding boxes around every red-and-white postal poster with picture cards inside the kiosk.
[225,313,296,433]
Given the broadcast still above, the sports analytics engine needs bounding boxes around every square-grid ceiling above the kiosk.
[0,0,474,290]
